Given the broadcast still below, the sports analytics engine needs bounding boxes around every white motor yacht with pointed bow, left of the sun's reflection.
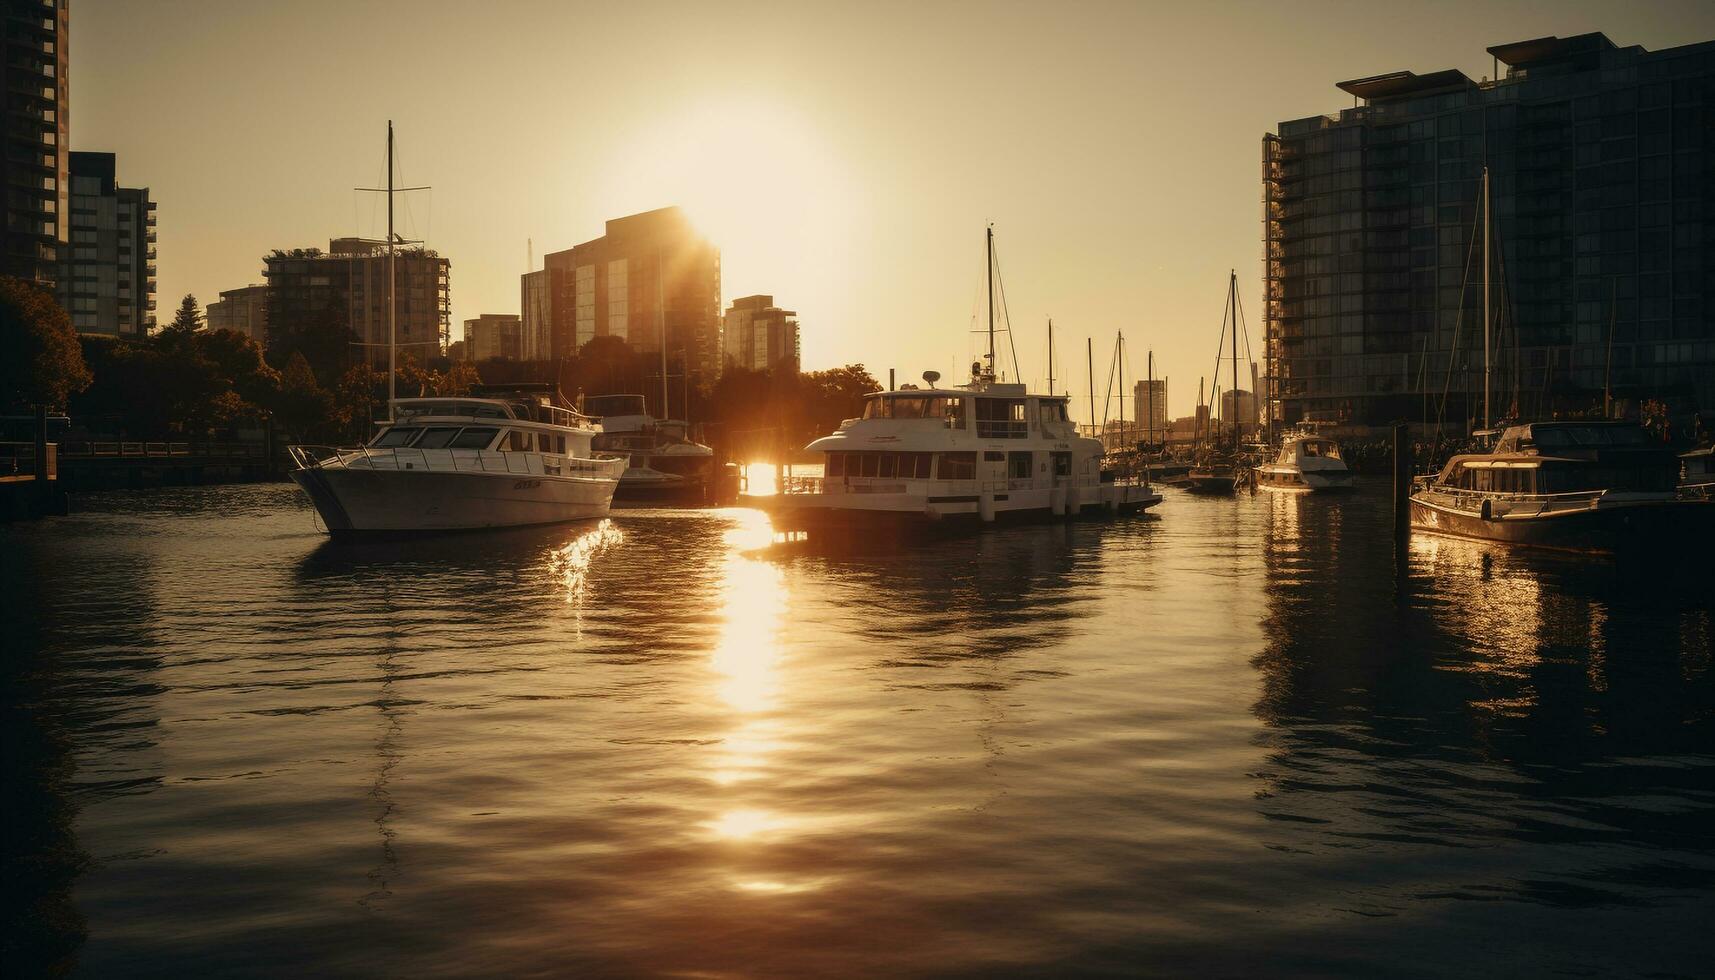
[290,386,626,537]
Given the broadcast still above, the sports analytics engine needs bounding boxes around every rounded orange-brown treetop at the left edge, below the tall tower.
[0,276,91,410]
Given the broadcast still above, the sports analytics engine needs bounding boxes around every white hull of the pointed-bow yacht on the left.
[292,467,617,537]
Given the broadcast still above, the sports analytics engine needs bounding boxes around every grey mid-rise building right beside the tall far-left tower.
[57,153,154,338]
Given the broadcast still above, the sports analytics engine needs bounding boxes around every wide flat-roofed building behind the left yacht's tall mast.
[264,239,453,364]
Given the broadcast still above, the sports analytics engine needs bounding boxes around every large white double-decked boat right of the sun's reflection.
[770,367,1161,530]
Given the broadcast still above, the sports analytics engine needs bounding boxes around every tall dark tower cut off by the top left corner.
[0,0,70,287]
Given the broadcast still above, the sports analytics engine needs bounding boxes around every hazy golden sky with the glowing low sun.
[70,0,1715,415]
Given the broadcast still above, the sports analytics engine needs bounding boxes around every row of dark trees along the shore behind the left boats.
[0,276,880,455]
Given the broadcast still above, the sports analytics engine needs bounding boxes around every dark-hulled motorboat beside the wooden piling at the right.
[1410,422,1715,554]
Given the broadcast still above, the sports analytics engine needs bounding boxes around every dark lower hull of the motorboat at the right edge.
[1410,494,1715,554]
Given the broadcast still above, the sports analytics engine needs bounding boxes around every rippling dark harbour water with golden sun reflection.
[0,486,1715,977]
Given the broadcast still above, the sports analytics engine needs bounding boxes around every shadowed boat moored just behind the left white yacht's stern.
[583,395,715,503]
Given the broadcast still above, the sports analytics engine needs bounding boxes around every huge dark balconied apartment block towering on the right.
[1262,34,1715,427]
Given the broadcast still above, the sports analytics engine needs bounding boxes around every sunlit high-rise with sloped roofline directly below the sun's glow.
[523,208,722,384]
